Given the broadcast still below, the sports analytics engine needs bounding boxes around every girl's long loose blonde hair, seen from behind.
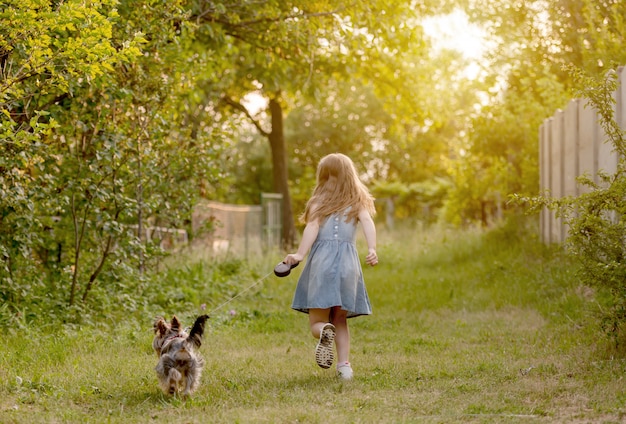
[300,153,376,223]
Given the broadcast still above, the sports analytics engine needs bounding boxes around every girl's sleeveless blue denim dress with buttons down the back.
[291,210,372,318]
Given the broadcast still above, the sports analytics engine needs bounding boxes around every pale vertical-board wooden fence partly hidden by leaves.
[539,66,626,243]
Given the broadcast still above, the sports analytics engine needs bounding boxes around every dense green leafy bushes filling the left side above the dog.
[0,1,221,320]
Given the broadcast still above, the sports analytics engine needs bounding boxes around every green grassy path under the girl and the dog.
[0,220,626,423]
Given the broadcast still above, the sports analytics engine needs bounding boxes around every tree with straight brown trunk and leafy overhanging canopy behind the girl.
[185,0,428,246]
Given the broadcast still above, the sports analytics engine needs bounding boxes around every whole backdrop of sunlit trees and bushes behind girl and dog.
[0,0,626,327]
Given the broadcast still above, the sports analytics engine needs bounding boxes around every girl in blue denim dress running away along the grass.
[283,153,378,380]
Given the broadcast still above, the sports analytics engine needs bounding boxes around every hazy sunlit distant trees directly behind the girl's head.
[276,41,472,227]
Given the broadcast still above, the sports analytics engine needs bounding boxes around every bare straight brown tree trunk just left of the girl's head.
[268,98,296,249]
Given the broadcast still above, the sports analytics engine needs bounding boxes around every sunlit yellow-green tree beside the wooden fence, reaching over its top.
[445,0,626,223]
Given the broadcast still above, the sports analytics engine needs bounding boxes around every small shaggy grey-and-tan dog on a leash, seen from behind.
[152,315,209,396]
